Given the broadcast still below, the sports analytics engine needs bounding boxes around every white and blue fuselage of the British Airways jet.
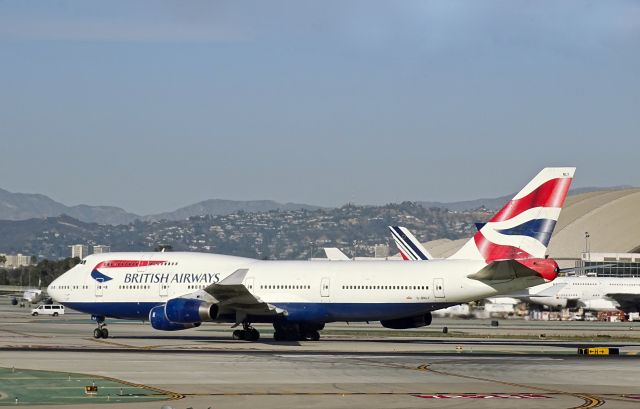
[49,252,543,322]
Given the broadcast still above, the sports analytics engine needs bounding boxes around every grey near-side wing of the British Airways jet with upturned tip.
[204,268,286,315]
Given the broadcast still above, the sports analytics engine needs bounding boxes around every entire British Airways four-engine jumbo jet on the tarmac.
[48,168,575,341]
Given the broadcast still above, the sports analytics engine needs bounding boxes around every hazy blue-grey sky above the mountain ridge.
[0,0,640,213]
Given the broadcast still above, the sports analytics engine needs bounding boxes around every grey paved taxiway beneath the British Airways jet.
[0,302,640,409]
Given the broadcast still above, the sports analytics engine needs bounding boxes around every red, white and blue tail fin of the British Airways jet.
[449,168,576,262]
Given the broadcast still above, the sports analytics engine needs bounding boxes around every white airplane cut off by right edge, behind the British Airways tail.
[518,276,640,313]
